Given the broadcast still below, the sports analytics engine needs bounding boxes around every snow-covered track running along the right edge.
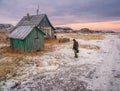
[89,36,120,91]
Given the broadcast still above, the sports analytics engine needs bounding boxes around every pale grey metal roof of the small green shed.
[8,26,45,39]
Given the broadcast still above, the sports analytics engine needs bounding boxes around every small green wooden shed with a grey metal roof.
[8,26,45,52]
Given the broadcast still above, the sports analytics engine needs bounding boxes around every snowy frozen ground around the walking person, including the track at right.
[0,35,120,91]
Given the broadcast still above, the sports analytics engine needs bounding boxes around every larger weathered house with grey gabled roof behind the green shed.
[16,14,55,39]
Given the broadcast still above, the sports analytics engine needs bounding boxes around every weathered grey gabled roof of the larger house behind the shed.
[16,14,54,29]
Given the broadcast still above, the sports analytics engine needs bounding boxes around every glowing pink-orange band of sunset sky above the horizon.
[56,21,120,31]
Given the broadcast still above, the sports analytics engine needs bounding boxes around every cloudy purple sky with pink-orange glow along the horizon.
[0,0,120,31]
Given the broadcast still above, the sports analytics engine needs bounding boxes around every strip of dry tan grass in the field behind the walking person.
[66,33,105,40]
